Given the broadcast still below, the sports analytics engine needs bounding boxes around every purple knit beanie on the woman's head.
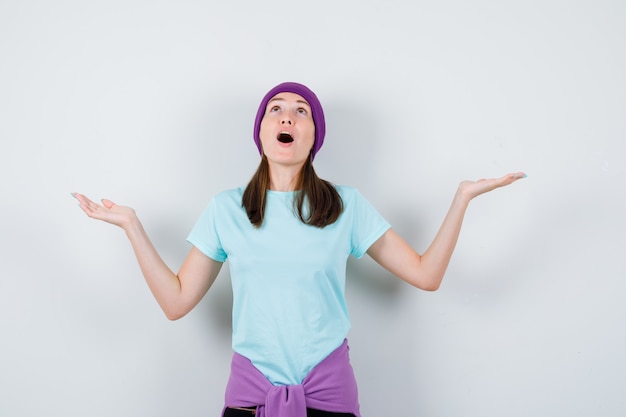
[254,83,326,159]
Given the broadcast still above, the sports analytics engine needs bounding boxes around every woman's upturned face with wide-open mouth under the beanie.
[259,93,315,165]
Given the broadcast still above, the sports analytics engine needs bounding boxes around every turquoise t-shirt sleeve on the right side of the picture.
[350,189,391,258]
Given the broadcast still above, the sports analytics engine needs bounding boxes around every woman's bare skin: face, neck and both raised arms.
[72,93,525,320]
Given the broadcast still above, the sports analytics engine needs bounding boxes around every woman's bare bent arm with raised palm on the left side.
[73,193,222,320]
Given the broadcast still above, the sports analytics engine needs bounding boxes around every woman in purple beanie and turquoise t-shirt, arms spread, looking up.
[74,83,525,417]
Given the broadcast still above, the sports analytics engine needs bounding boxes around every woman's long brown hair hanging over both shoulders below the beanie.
[241,155,343,228]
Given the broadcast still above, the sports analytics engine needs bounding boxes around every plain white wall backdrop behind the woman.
[0,0,626,417]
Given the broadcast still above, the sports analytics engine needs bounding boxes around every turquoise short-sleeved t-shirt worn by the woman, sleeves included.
[187,186,390,385]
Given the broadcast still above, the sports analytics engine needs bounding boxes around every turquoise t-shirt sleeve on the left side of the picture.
[187,198,227,262]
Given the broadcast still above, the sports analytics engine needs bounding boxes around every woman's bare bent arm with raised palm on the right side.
[367,172,525,291]
